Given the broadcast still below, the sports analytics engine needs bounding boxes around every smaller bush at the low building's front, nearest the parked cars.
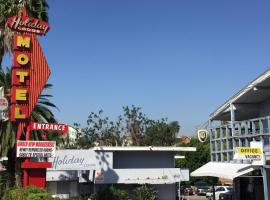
[135,185,158,200]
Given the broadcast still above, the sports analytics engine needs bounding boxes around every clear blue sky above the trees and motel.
[3,0,270,135]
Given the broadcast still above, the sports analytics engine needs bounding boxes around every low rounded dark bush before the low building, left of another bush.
[95,187,129,200]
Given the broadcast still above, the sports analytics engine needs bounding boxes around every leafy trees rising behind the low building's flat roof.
[73,106,180,148]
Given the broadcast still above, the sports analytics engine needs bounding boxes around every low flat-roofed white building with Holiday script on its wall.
[46,146,196,200]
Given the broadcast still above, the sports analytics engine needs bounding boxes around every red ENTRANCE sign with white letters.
[30,122,68,133]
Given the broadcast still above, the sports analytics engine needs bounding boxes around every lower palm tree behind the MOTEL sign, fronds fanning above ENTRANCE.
[0,68,58,186]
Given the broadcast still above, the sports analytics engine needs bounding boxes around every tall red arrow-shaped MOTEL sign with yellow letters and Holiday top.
[6,8,50,139]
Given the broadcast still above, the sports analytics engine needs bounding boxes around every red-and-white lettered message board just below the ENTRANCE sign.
[17,140,56,158]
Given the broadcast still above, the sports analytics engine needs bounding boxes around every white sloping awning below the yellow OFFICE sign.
[191,162,255,179]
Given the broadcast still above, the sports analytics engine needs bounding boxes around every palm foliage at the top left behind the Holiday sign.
[0,0,49,65]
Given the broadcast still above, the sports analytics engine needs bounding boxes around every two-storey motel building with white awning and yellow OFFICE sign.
[191,69,270,200]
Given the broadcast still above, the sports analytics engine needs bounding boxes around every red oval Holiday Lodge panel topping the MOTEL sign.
[7,16,50,35]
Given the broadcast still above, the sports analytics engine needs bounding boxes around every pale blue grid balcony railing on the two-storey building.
[210,116,270,162]
